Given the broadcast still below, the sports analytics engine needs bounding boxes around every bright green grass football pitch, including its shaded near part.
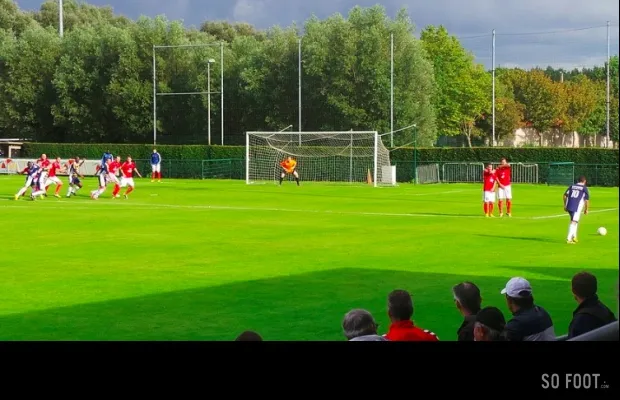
[0,176,618,341]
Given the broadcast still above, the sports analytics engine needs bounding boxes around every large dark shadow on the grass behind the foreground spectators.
[0,269,613,340]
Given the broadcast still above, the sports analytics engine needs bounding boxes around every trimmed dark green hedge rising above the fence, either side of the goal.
[22,143,620,164]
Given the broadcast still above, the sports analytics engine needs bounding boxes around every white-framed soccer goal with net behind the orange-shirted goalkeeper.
[245,131,396,186]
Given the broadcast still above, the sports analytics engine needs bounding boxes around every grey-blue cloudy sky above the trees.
[16,0,619,68]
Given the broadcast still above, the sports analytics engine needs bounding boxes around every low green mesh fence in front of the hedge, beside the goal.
[131,158,619,187]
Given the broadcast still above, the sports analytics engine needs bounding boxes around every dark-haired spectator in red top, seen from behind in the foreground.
[384,290,439,342]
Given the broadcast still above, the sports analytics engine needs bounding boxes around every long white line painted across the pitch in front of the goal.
[1,199,618,220]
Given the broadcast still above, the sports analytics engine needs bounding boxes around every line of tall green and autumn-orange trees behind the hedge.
[0,0,618,146]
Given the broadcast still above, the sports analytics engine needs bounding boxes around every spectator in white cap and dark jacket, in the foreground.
[501,277,556,342]
